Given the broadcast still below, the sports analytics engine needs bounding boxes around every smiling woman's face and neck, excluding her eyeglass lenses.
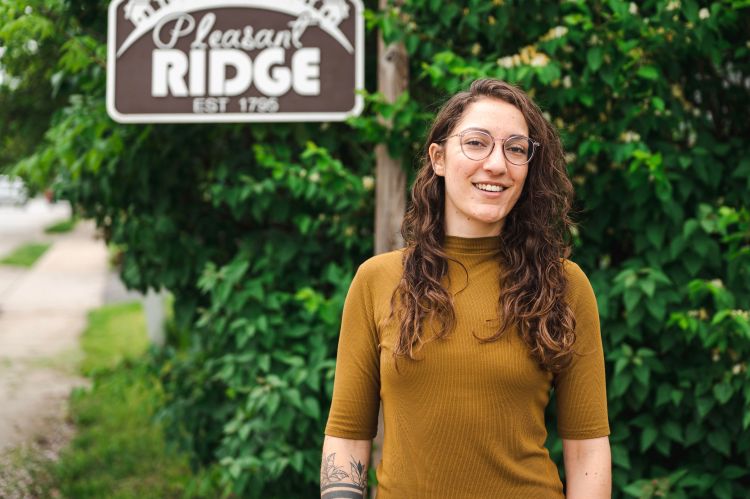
[429,97,529,237]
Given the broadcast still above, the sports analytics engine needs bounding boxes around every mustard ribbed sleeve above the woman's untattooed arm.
[555,261,610,440]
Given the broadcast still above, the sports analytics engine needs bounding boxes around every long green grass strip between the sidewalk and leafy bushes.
[40,303,220,499]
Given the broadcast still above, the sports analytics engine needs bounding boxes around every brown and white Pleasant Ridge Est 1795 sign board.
[107,0,364,123]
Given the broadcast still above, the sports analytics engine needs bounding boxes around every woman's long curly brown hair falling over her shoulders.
[391,79,575,372]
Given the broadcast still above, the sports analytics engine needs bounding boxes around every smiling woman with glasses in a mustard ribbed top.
[321,79,611,499]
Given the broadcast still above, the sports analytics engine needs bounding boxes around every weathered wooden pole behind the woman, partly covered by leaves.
[370,0,409,492]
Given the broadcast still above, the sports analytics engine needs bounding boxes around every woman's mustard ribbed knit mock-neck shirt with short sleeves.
[325,236,609,499]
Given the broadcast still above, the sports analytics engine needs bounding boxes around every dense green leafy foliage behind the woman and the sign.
[0,0,750,499]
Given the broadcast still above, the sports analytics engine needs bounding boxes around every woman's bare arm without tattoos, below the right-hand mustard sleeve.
[563,437,612,499]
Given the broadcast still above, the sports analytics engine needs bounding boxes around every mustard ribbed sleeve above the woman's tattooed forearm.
[325,267,380,440]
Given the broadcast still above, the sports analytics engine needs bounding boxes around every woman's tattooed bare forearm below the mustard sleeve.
[320,435,372,499]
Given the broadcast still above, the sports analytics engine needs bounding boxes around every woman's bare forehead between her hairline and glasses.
[454,97,529,137]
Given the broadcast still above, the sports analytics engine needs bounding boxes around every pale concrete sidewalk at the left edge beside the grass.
[0,222,109,452]
